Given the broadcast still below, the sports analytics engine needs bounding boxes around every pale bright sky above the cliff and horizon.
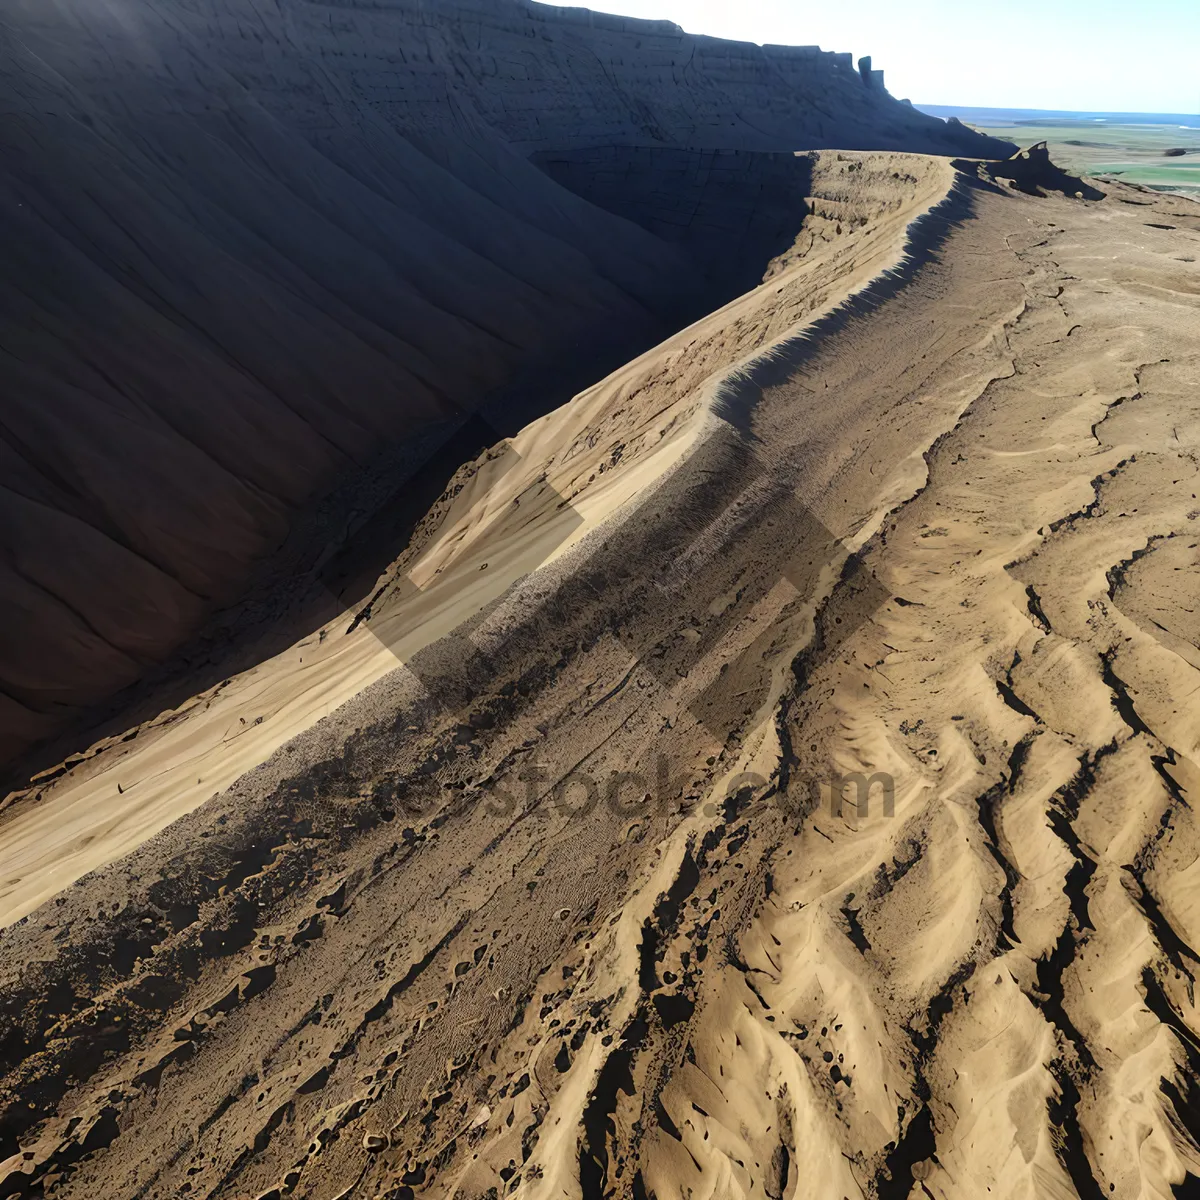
[547,0,1200,113]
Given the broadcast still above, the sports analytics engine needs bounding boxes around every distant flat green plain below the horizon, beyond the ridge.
[974,119,1200,197]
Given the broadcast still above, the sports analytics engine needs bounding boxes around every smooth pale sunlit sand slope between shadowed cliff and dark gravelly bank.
[0,156,949,923]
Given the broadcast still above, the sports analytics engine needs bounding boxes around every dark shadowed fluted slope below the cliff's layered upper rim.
[0,63,702,750]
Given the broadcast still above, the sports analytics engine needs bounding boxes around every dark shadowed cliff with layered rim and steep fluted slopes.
[0,0,995,757]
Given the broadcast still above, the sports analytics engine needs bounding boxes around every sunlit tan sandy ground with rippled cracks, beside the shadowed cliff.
[0,151,1200,1200]
